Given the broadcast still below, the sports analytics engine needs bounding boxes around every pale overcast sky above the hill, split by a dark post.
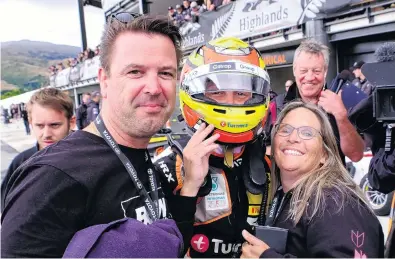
[0,0,105,48]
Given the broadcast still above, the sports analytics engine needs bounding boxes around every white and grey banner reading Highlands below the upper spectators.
[180,0,357,49]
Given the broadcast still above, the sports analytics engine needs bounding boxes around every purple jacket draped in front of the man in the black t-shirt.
[63,218,183,258]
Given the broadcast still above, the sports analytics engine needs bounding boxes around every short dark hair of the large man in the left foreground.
[100,15,182,74]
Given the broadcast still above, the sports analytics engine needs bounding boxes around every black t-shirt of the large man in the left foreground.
[1,131,170,257]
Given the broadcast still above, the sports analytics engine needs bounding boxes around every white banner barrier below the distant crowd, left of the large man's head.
[49,56,100,87]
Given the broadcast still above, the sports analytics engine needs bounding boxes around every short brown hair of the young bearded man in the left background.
[27,88,73,120]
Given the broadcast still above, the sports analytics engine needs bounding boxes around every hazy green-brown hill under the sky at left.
[1,40,81,94]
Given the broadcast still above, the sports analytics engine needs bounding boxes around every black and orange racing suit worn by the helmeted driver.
[154,135,270,258]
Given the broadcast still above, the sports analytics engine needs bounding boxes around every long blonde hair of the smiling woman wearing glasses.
[271,100,369,225]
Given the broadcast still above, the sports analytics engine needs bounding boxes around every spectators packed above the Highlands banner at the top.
[168,0,234,26]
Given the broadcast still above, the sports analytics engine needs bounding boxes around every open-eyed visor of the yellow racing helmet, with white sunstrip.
[183,72,270,106]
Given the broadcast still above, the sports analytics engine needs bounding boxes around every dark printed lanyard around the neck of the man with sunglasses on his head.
[95,114,159,221]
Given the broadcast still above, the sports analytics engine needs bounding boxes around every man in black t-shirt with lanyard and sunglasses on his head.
[1,13,196,257]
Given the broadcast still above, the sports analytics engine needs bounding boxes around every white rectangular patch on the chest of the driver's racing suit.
[204,174,229,210]
